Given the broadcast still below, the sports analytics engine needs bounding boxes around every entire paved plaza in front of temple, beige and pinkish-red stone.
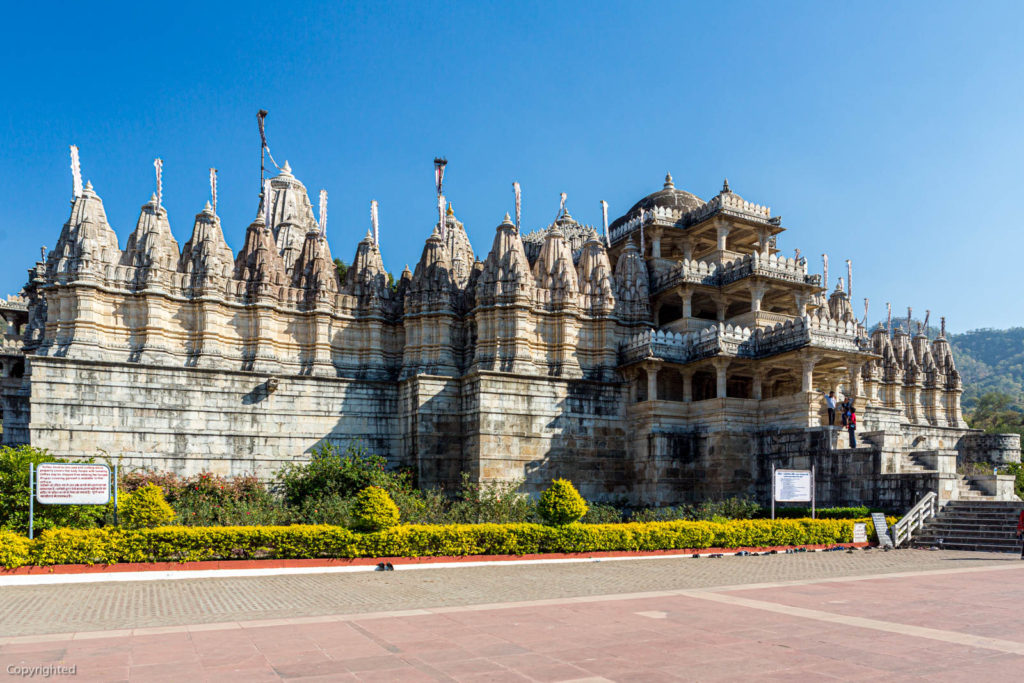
[0,550,1024,683]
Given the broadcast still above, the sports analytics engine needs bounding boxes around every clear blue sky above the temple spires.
[0,1,1024,331]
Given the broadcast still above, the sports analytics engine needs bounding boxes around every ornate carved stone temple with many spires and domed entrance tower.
[0,156,1020,506]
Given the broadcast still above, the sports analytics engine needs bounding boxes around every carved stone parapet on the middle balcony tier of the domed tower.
[651,252,820,293]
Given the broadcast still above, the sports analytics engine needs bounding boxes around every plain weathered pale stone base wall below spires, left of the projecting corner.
[20,356,402,477]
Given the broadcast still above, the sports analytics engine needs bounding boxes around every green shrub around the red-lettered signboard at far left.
[0,445,104,533]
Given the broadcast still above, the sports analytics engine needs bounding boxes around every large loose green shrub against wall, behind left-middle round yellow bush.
[278,443,412,507]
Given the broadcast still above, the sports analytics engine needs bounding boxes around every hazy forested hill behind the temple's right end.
[949,328,1024,410]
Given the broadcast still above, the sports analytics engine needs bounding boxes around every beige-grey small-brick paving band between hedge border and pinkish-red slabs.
[0,550,1020,637]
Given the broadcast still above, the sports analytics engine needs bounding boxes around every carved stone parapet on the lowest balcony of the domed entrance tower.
[620,315,864,365]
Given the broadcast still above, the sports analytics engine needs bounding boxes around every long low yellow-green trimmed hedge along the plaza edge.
[0,519,888,568]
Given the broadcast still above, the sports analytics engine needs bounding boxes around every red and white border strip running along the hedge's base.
[0,543,872,578]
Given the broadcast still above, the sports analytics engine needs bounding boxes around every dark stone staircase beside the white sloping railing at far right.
[911,501,1024,553]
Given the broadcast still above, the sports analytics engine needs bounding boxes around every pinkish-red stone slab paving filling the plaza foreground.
[0,553,1024,683]
